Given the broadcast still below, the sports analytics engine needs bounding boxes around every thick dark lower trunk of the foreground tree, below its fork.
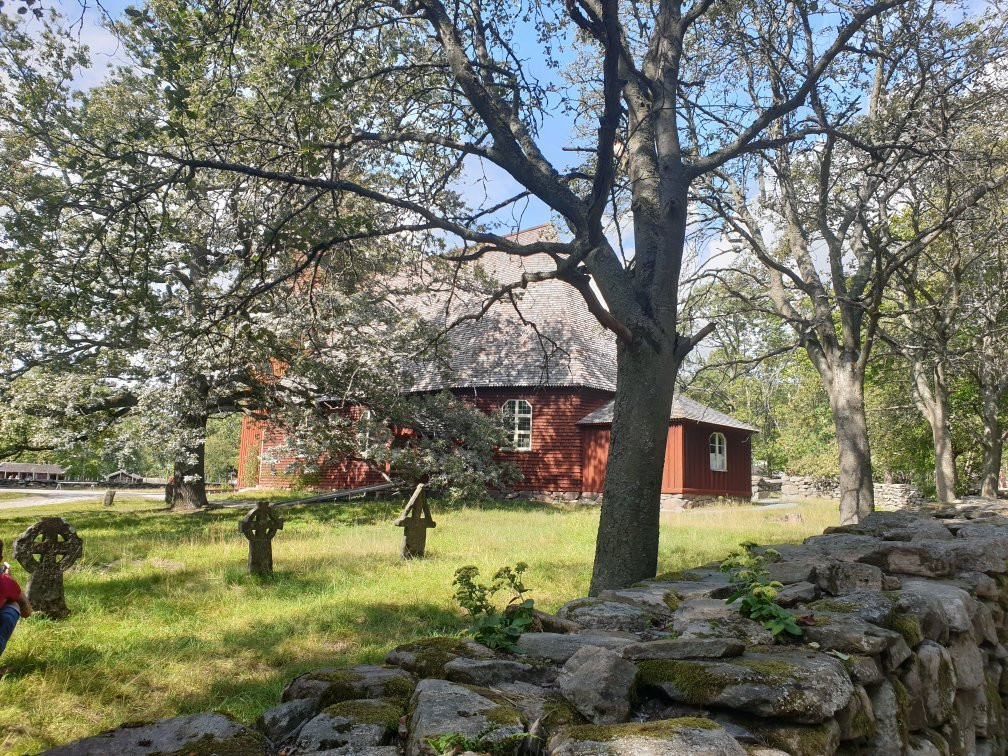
[590,342,679,596]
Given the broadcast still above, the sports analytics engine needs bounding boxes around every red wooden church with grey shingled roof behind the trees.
[239,226,756,501]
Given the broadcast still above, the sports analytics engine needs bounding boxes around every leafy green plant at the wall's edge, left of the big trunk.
[452,561,535,651]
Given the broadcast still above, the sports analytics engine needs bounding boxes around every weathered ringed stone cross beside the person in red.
[14,517,84,620]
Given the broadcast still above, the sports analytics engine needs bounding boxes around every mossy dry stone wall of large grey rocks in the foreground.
[50,503,1008,756]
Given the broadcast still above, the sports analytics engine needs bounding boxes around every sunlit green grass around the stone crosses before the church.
[0,497,837,754]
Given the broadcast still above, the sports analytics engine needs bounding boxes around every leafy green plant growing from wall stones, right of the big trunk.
[721,543,804,638]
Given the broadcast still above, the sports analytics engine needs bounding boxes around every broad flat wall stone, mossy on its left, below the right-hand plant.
[637,651,854,724]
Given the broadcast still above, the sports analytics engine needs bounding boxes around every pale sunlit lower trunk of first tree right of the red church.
[810,354,875,525]
